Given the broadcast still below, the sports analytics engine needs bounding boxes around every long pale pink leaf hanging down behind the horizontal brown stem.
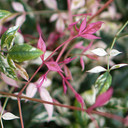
[39,87,53,120]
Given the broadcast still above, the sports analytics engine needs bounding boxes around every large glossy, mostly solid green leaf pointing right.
[8,44,43,62]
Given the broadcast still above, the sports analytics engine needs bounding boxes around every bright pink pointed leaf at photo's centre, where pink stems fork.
[45,61,63,72]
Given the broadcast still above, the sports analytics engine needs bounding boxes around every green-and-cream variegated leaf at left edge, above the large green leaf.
[1,26,19,49]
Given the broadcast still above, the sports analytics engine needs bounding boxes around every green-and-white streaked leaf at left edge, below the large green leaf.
[0,54,17,80]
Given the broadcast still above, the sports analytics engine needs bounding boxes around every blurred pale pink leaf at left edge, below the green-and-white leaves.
[1,73,19,88]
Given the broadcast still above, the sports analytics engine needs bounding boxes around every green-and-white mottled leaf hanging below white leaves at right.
[95,72,112,94]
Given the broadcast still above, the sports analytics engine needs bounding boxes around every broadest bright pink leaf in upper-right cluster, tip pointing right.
[83,21,103,34]
